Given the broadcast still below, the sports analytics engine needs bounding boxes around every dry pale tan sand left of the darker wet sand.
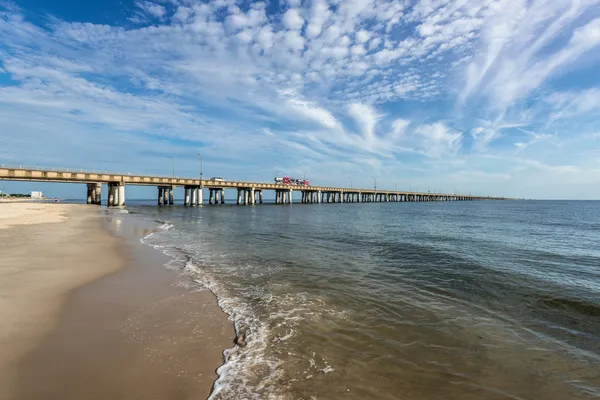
[0,203,122,399]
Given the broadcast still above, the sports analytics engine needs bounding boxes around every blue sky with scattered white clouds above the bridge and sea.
[0,0,600,198]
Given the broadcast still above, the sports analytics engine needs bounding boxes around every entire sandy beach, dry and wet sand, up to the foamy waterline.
[0,203,233,399]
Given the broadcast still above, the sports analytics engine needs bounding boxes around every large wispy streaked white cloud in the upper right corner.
[461,1,600,110]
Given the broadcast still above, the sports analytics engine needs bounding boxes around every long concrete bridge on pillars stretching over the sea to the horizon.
[0,165,507,207]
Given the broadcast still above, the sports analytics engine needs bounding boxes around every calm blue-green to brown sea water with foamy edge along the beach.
[128,201,600,400]
